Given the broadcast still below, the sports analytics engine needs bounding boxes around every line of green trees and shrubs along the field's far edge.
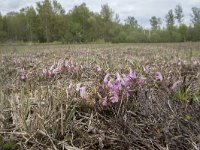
[0,0,200,43]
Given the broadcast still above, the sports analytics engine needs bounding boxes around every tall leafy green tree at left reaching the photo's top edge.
[36,0,65,42]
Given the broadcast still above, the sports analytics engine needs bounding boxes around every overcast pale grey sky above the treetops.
[0,0,200,28]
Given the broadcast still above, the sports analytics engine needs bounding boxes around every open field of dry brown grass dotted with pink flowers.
[0,43,200,150]
